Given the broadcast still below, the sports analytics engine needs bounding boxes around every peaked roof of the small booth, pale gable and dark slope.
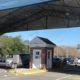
[29,37,56,48]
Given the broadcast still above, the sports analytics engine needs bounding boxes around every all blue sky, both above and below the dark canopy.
[0,0,80,46]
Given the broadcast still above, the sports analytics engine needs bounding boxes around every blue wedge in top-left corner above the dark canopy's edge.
[0,0,49,10]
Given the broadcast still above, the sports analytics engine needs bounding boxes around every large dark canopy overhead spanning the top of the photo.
[0,0,80,34]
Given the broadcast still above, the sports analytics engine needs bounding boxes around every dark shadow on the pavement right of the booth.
[49,65,80,75]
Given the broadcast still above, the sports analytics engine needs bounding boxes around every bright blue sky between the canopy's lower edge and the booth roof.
[5,27,80,47]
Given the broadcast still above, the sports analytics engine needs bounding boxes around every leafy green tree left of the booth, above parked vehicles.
[0,36,28,55]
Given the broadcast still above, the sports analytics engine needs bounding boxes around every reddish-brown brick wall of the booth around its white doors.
[30,47,54,69]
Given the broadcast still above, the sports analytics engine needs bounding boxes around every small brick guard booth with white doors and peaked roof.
[30,37,55,69]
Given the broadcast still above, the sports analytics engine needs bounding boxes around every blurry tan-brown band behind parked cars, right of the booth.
[54,46,80,58]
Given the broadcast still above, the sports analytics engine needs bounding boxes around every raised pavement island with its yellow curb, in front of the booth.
[8,68,47,75]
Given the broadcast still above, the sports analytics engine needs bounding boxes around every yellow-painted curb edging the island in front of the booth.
[8,70,48,75]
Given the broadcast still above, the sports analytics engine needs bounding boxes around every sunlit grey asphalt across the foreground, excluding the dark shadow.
[0,71,80,80]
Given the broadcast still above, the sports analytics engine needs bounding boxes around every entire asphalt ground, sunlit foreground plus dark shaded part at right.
[0,66,80,80]
